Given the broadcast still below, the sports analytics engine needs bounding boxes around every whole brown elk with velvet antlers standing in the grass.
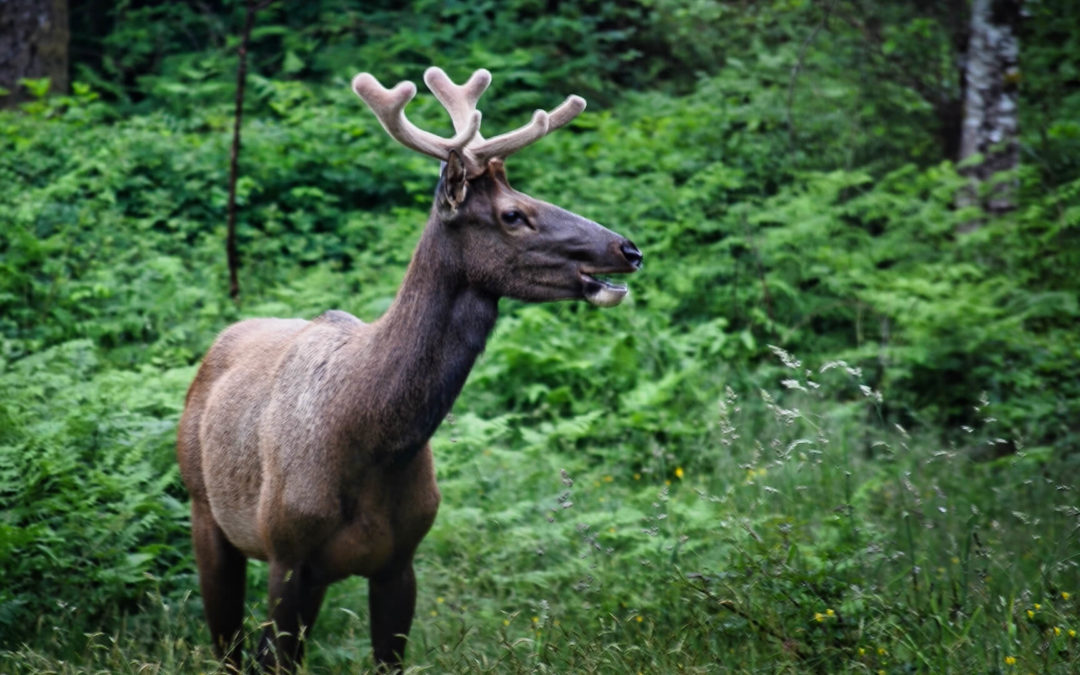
[177,68,642,671]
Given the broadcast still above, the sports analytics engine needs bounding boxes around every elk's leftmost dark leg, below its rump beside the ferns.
[191,500,247,673]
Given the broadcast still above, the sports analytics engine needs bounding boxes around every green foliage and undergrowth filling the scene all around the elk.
[0,0,1080,672]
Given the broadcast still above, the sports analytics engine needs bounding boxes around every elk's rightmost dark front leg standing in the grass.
[367,559,416,673]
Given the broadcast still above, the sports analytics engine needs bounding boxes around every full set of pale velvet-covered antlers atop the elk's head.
[352,67,585,176]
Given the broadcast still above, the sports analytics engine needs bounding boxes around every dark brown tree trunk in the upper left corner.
[0,0,70,106]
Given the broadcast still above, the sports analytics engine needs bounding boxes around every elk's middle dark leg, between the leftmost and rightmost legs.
[258,561,326,673]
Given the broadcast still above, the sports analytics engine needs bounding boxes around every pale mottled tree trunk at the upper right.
[957,0,1021,217]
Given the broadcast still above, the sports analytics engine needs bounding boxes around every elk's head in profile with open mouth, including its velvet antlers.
[352,67,642,307]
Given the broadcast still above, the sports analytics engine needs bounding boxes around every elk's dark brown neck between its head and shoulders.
[358,214,499,460]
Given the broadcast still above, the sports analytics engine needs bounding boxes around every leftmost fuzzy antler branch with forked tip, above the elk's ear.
[352,72,481,161]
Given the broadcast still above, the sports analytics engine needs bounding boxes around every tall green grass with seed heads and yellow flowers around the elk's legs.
[0,352,1080,673]
